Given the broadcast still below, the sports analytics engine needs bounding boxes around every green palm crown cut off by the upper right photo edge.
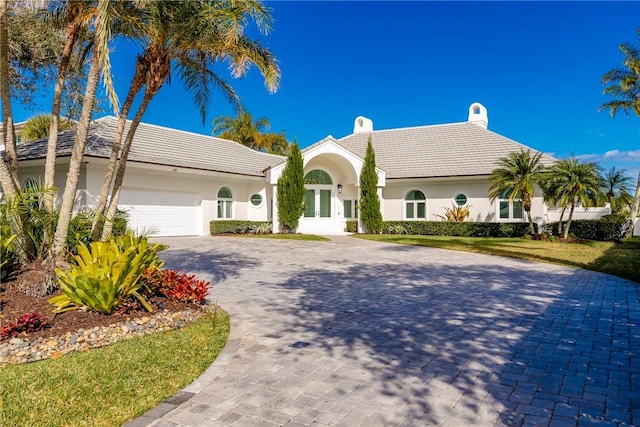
[598,28,640,117]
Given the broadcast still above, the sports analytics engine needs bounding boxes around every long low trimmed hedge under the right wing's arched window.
[382,221,537,237]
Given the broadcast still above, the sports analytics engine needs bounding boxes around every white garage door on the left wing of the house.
[118,188,201,236]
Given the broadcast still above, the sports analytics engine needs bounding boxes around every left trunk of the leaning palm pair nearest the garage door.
[91,60,146,241]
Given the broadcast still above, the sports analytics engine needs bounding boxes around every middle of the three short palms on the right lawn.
[550,157,604,239]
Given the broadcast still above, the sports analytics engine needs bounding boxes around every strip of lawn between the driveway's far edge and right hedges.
[357,234,640,283]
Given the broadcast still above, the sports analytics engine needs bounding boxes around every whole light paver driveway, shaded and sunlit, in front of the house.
[134,237,640,426]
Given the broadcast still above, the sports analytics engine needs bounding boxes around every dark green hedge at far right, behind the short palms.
[543,214,631,242]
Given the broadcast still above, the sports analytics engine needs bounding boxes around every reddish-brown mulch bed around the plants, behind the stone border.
[0,264,193,342]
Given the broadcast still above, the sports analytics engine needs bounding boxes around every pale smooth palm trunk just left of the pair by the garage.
[52,50,101,258]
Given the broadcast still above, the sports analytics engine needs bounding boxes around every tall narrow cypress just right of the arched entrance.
[360,137,382,234]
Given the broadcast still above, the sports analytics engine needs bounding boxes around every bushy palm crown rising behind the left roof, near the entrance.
[213,111,289,154]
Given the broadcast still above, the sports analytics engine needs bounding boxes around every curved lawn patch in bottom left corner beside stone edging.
[0,311,229,426]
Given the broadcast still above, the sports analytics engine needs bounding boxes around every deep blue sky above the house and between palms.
[14,1,640,175]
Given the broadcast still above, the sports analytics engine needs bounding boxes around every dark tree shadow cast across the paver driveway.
[274,262,640,425]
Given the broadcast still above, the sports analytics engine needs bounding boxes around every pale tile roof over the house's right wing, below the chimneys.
[338,122,555,179]
